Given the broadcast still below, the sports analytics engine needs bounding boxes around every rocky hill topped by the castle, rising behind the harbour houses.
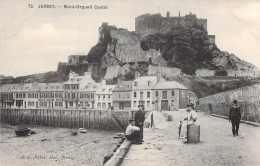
[1,11,258,96]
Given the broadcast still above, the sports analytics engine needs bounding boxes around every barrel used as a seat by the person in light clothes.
[187,124,200,143]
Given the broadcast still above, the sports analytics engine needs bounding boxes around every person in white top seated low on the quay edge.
[125,119,141,144]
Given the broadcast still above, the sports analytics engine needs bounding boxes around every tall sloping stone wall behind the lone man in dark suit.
[197,84,260,123]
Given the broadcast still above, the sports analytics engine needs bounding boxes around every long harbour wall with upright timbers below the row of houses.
[0,108,135,130]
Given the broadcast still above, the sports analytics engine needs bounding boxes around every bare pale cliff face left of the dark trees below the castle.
[102,29,167,67]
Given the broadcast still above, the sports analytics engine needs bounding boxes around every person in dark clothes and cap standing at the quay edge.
[135,105,145,142]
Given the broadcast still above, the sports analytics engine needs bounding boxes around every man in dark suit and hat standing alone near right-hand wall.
[229,100,241,136]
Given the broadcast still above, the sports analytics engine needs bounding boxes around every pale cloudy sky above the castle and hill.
[0,0,260,77]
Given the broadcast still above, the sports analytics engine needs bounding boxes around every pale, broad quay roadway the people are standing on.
[122,111,260,166]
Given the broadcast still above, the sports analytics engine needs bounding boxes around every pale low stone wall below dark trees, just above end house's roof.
[148,65,181,76]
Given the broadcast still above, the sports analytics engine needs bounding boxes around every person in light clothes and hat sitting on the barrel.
[181,103,197,138]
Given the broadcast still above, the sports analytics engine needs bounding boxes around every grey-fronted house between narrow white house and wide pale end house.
[113,81,133,110]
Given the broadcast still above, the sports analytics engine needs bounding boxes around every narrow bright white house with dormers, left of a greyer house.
[95,80,116,109]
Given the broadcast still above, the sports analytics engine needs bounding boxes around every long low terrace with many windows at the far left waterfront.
[0,83,64,108]
